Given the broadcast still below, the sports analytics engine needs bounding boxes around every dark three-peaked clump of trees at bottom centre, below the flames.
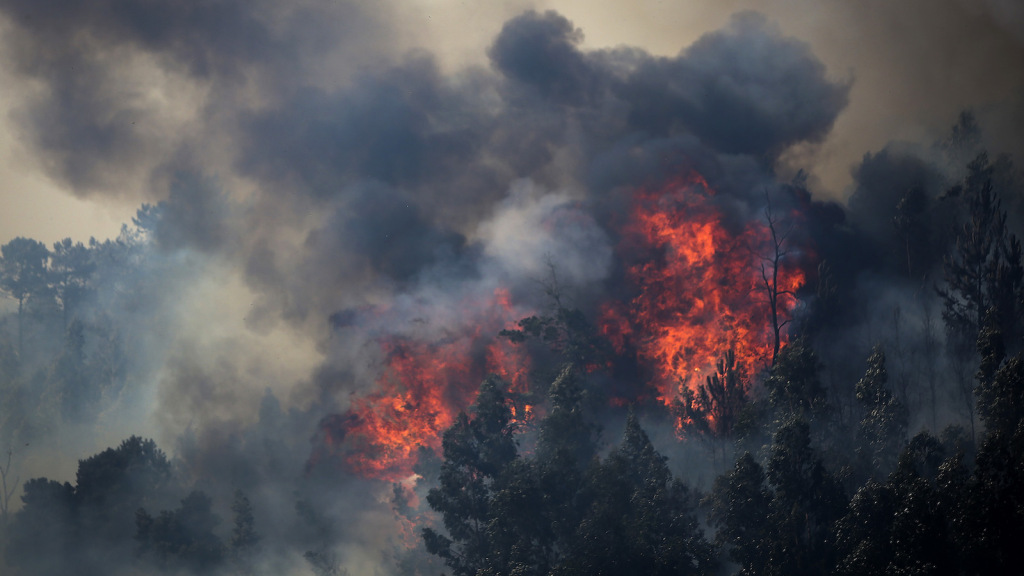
[423,377,714,576]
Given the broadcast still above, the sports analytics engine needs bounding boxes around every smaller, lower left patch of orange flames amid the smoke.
[321,290,531,482]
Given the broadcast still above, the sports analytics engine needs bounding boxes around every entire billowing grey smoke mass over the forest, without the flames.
[0,0,1020,573]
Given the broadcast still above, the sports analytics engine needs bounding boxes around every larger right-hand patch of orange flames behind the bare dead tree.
[600,173,804,412]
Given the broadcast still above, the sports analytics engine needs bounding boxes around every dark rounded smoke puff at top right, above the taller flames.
[623,12,849,160]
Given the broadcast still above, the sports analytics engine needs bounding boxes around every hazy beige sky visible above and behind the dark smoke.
[0,0,1024,243]
